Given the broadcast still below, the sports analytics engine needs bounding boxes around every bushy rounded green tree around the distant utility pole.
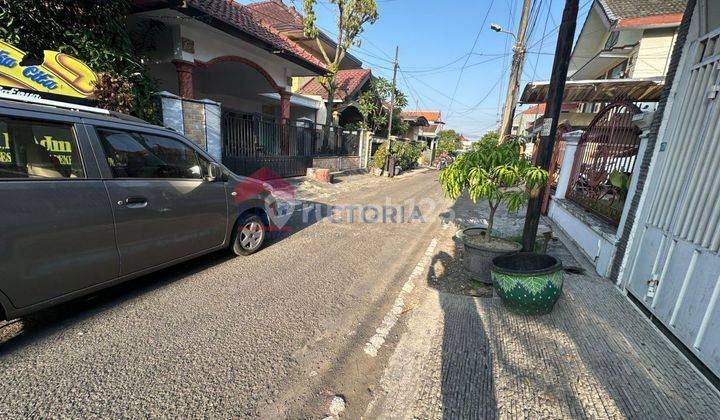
[358,77,407,135]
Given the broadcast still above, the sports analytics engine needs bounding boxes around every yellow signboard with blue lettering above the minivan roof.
[0,41,97,99]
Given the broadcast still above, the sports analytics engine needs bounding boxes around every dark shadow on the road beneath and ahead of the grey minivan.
[0,202,329,357]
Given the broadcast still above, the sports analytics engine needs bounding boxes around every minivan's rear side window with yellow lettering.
[0,117,85,178]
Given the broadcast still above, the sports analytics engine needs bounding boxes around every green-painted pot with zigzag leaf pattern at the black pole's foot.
[491,252,563,315]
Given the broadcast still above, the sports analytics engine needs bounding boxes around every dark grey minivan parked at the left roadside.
[0,100,275,319]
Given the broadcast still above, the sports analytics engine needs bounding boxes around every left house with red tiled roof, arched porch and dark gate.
[128,0,368,176]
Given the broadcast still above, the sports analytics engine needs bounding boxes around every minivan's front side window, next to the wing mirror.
[97,128,205,179]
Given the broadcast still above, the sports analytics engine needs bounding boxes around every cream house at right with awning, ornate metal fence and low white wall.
[520,0,688,276]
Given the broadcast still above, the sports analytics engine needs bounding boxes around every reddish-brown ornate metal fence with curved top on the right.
[566,102,640,226]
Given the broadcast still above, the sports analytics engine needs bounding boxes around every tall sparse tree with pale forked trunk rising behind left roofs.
[303,0,379,126]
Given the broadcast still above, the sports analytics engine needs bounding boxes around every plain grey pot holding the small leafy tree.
[458,227,522,284]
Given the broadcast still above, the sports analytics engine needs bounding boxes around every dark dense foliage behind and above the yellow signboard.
[0,0,160,122]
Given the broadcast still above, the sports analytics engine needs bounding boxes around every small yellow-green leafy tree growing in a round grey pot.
[440,136,547,284]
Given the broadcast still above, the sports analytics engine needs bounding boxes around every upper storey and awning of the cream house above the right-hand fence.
[521,0,687,113]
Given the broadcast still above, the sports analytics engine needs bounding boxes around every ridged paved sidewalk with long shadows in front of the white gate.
[366,199,720,419]
